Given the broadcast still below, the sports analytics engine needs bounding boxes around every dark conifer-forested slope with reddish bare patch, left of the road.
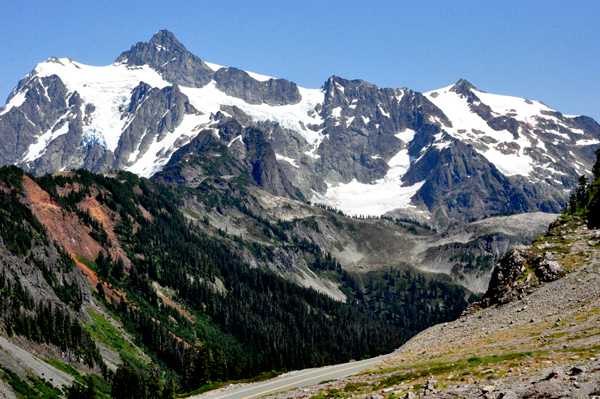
[0,164,474,394]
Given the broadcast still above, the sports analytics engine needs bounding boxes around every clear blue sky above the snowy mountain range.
[0,0,600,121]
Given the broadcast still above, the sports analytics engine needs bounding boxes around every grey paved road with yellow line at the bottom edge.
[189,355,389,399]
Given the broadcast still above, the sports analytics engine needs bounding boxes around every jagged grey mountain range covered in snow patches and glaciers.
[0,31,600,224]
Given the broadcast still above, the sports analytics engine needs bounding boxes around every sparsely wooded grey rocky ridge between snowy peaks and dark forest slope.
[152,138,556,298]
